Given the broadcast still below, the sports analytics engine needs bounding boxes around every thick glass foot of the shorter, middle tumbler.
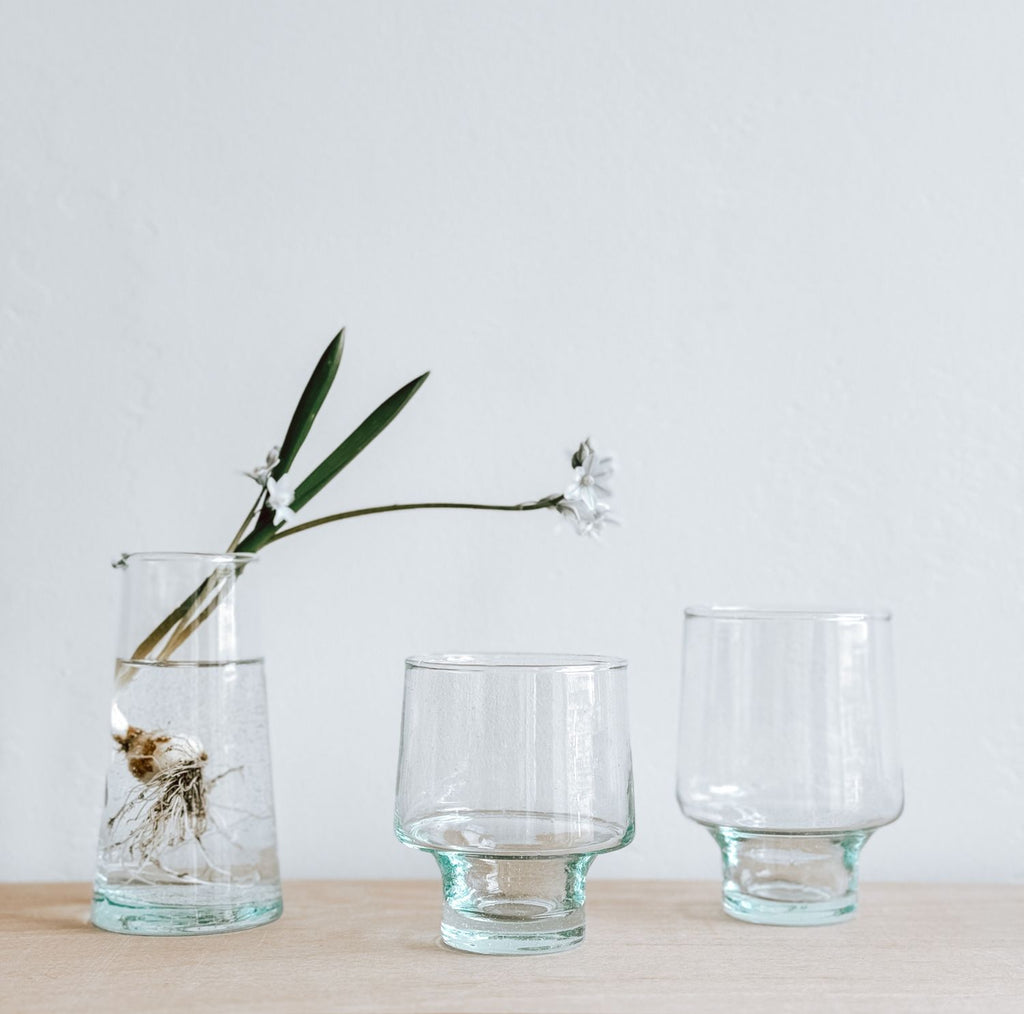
[433,852,594,955]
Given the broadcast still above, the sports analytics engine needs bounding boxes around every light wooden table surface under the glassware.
[0,880,1024,1014]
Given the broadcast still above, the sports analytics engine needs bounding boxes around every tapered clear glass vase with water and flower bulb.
[92,553,282,936]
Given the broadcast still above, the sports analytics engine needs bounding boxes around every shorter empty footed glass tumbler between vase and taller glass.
[395,654,634,955]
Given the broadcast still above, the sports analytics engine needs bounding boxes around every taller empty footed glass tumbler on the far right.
[678,607,903,926]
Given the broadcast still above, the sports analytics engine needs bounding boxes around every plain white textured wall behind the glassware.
[0,0,1024,881]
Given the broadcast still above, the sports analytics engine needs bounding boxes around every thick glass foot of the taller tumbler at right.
[711,828,870,926]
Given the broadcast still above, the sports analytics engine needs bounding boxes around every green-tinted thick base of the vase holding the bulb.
[91,886,283,936]
